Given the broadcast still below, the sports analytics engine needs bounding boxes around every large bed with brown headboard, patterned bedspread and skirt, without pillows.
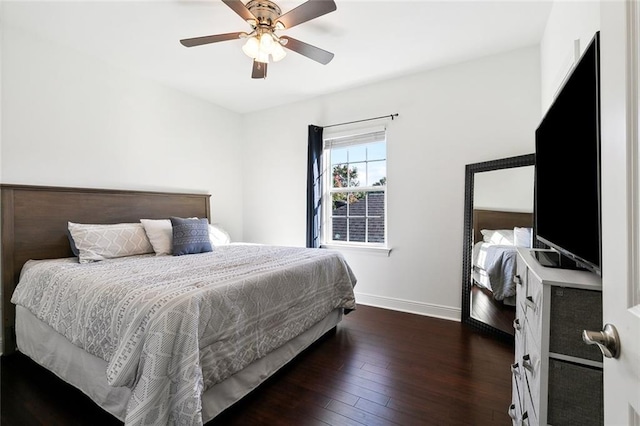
[1,185,355,425]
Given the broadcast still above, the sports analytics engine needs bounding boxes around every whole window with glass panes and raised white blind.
[322,129,387,247]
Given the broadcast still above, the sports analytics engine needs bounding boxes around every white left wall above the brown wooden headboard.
[0,25,242,239]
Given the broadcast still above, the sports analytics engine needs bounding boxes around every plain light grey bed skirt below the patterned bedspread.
[16,306,342,422]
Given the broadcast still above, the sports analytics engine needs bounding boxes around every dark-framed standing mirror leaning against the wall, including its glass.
[462,154,535,341]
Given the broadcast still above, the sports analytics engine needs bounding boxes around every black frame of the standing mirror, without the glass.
[461,154,535,342]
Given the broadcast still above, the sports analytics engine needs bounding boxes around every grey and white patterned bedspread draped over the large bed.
[11,245,356,425]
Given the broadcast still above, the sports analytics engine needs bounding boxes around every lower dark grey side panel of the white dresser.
[547,358,604,426]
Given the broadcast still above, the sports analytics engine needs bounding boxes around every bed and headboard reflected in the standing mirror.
[471,209,533,333]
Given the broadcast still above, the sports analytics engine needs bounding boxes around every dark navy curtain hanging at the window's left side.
[307,124,322,248]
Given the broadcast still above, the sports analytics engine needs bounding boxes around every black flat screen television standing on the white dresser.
[534,32,602,275]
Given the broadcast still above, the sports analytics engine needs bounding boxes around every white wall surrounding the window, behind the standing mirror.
[243,47,541,319]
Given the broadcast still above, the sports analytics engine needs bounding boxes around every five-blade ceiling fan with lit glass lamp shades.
[180,0,336,78]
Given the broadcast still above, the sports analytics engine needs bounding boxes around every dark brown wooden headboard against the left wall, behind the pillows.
[0,185,210,354]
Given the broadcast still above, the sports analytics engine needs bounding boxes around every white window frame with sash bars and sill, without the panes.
[320,127,390,250]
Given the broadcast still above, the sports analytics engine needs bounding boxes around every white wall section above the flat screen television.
[540,1,600,115]
